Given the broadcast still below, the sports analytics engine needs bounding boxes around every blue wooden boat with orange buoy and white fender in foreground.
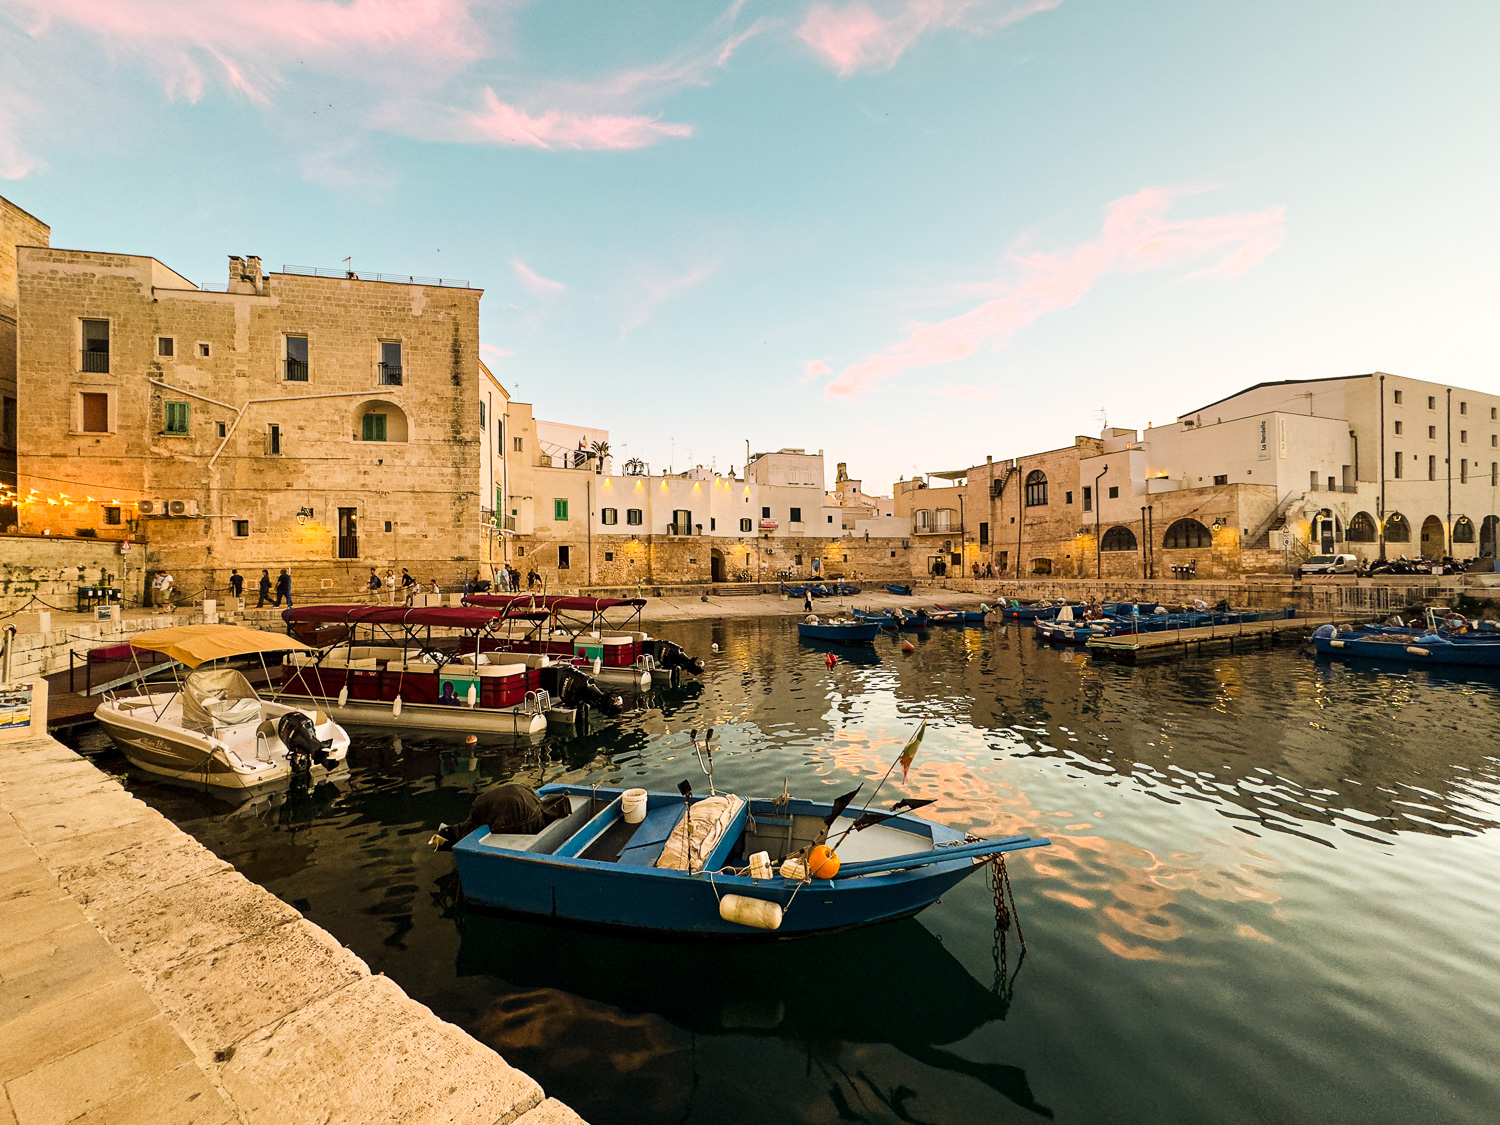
[453,785,1050,941]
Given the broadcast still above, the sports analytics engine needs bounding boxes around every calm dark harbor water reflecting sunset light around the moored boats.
[85,621,1500,1125]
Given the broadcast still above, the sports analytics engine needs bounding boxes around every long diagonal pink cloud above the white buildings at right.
[824,188,1286,399]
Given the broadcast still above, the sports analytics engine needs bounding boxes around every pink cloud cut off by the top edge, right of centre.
[797,0,1062,78]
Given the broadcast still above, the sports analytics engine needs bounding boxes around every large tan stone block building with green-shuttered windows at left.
[17,245,495,596]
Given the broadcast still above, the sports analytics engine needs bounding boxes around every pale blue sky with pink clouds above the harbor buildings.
[0,0,1500,492]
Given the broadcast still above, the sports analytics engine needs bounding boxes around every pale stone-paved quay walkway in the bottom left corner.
[0,740,581,1125]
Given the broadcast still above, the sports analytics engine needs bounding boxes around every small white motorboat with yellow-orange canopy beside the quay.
[95,626,350,794]
